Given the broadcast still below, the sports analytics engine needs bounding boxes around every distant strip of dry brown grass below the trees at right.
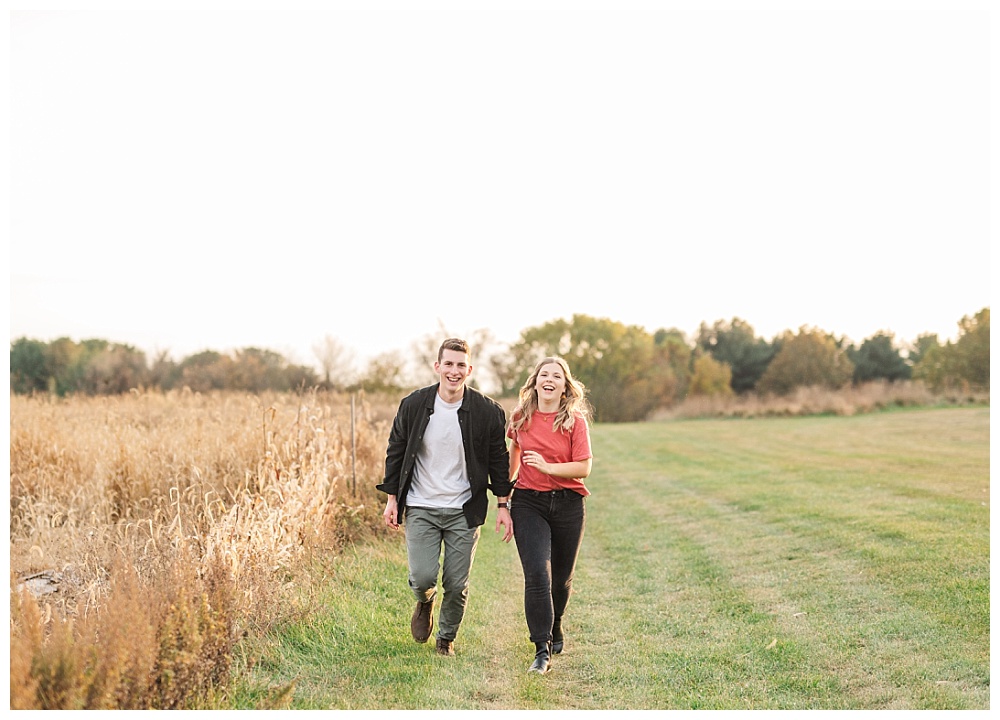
[650,382,990,420]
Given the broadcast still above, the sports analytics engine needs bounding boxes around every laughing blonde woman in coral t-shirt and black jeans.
[507,357,592,673]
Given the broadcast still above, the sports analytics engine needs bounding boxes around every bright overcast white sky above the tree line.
[9,0,991,376]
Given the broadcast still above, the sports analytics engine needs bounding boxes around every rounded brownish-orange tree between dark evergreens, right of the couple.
[757,327,854,395]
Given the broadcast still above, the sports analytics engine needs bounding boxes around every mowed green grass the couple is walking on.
[228,408,990,709]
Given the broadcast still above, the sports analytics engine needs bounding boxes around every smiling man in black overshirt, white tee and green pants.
[376,338,514,656]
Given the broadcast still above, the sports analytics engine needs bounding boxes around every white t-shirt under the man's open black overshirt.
[406,395,472,508]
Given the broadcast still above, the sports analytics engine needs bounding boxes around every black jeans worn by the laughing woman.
[510,488,586,642]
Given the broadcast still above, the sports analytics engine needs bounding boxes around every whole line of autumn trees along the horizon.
[10,307,990,422]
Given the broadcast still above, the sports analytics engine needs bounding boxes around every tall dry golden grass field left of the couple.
[10,392,394,708]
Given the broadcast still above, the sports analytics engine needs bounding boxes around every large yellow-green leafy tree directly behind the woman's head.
[511,315,675,422]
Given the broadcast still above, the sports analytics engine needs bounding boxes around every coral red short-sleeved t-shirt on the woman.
[507,410,593,497]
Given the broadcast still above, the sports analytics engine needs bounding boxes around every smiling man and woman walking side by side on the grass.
[376,338,592,673]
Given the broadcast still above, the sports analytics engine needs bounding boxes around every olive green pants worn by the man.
[404,507,479,640]
